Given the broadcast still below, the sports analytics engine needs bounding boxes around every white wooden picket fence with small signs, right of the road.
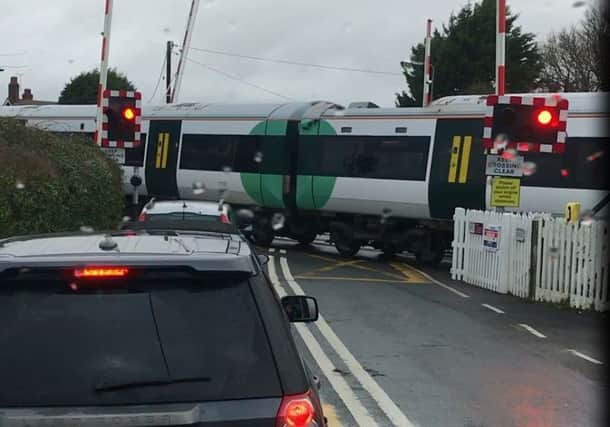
[451,208,608,311]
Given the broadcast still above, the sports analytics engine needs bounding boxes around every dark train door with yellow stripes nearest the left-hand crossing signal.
[146,120,182,198]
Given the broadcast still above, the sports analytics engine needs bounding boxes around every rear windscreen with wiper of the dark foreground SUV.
[0,274,281,407]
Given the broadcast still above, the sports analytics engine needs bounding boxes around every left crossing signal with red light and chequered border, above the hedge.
[101,90,142,148]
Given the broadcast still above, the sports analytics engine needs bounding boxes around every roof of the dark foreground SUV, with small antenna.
[0,229,257,273]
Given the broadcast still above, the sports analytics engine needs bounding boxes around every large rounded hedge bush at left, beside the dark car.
[0,119,124,237]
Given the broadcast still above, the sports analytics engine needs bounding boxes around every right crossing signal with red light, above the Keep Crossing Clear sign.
[483,95,568,153]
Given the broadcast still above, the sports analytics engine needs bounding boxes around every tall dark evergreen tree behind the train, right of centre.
[396,0,542,107]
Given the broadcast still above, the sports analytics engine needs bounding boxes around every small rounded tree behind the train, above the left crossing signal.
[57,68,136,104]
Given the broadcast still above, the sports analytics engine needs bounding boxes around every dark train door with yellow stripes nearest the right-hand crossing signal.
[428,119,485,219]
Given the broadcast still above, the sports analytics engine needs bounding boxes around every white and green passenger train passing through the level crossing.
[0,93,610,263]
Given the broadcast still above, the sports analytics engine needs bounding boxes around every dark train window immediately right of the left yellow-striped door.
[180,134,238,171]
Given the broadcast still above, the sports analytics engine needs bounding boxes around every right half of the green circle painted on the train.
[296,120,337,210]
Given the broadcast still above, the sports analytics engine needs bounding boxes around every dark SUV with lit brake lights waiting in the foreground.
[0,223,324,427]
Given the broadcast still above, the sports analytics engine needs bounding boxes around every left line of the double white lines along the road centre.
[267,255,378,427]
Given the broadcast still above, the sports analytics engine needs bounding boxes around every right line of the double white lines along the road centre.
[280,257,414,427]
